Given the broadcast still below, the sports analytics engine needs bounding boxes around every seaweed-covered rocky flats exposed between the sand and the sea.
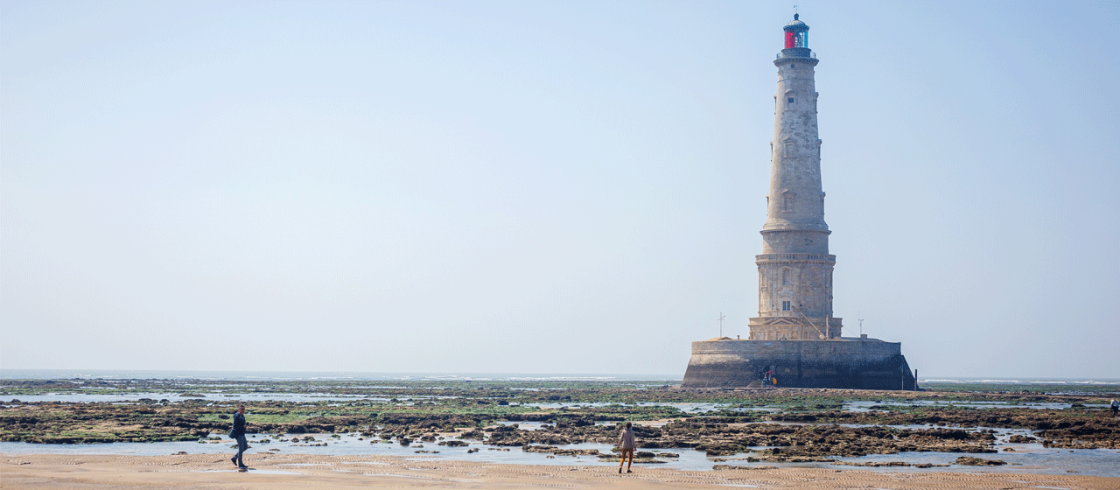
[0,380,1120,463]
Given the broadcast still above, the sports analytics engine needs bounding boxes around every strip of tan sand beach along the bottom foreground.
[0,454,1120,490]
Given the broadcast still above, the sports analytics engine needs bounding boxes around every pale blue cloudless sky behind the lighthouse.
[0,0,1120,377]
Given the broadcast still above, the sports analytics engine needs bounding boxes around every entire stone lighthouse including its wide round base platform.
[682,15,917,389]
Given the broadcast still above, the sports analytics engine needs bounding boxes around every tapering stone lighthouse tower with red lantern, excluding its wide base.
[750,15,841,340]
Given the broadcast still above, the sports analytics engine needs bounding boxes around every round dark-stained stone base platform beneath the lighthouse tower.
[683,337,917,389]
